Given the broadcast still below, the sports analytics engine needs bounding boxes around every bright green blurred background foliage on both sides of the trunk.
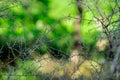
[0,0,118,57]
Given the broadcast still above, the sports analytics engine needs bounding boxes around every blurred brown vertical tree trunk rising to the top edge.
[70,0,83,68]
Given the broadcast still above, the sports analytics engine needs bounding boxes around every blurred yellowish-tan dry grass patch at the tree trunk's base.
[35,54,100,79]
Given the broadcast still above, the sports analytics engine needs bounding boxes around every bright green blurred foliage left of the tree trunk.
[0,0,76,56]
